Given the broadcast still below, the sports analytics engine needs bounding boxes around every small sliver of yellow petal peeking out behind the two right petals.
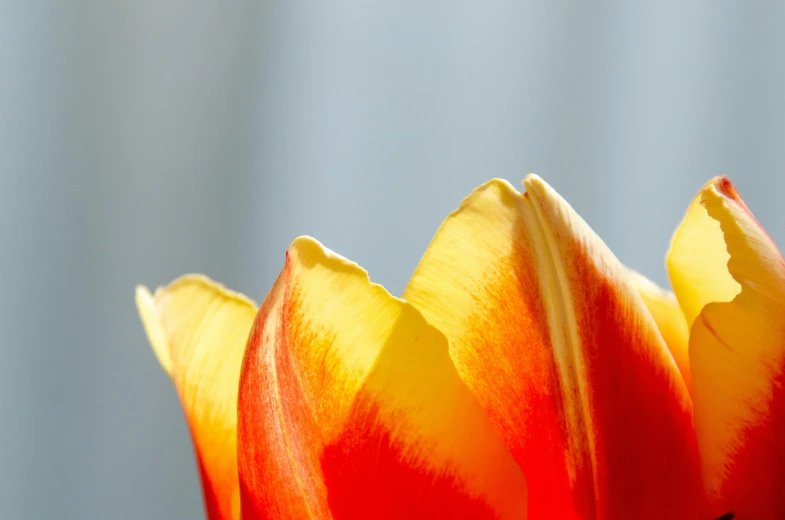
[629,269,692,390]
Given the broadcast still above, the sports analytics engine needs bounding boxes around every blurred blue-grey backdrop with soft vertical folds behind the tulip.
[0,0,785,520]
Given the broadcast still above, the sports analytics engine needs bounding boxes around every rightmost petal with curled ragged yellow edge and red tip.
[668,177,785,519]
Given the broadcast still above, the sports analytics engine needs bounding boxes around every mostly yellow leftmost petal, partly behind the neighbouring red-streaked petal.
[136,275,256,520]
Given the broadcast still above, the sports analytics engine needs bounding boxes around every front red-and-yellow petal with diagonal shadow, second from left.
[238,238,526,520]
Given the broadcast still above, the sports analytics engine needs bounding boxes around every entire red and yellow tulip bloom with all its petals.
[136,176,785,520]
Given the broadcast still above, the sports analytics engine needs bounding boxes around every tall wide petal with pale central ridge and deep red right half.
[404,176,702,520]
